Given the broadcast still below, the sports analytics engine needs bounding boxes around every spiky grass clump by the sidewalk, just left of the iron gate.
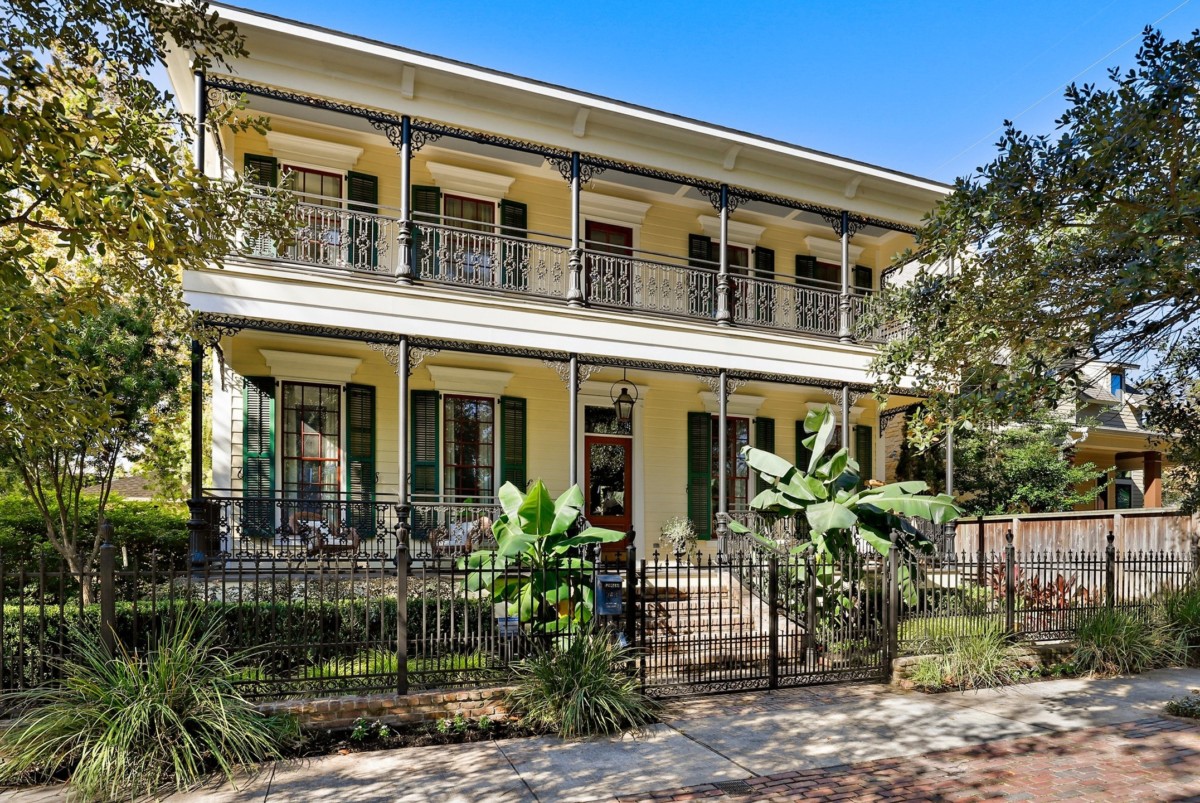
[509,630,655,738]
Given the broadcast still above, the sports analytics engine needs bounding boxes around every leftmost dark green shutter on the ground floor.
[241,377,275,538]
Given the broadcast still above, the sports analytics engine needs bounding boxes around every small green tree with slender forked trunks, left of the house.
[0,298,184,592]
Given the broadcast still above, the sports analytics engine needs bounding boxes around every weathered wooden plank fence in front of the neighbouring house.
[954,508,1200,553]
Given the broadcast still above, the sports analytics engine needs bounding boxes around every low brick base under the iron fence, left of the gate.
[258,687,510,729]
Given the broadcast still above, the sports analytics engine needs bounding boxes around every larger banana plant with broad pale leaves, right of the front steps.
[730,406,961,599]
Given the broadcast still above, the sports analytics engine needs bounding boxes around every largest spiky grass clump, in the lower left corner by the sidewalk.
[0,619,298,801]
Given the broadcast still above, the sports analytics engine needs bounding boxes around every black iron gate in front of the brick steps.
[630,549,895,697]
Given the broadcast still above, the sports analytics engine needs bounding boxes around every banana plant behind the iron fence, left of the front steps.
[460,480,625,636]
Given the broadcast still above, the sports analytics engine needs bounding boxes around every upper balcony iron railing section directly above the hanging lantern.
[583,252,716,320]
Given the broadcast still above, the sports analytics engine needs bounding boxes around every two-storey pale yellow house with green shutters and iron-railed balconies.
[168,6,949,555]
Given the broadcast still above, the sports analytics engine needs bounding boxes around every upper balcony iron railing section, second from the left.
[413,223,569,299]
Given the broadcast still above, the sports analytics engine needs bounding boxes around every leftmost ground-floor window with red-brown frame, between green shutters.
[282,382,342,499]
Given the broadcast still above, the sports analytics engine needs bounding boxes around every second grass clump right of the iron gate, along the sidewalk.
[1072,609,1180,675]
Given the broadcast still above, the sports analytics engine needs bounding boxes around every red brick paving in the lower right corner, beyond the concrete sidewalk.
[619,718,1200,803]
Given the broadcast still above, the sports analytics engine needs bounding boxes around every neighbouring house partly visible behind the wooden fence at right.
[1063,361,1163,510]
